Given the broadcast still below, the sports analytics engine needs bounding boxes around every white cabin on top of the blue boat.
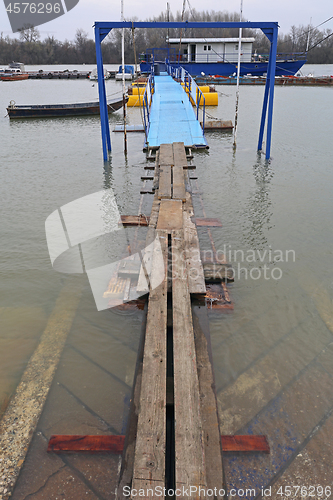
[168,38,254,63]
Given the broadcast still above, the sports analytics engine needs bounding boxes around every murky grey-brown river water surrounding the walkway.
[0,65,333,496]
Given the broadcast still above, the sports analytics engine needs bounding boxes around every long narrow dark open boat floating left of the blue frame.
[7,97,128,118]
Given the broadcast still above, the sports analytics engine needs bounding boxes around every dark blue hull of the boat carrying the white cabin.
[140,59,306,76]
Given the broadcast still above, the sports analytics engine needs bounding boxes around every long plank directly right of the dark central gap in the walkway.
[171,231,206,498]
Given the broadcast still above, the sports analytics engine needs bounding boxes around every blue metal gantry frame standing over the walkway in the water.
[94,21,279,161]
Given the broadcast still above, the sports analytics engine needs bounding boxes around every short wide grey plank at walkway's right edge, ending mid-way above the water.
[183,193,206,294]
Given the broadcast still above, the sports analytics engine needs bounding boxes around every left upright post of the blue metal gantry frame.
[95,27,111,161]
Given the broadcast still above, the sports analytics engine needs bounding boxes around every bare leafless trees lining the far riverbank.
[0,9,333,65]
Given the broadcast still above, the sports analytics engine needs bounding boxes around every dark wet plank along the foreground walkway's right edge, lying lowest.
[192,306,223,500]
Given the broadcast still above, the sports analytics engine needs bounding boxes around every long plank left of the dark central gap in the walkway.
[132,231,168,489]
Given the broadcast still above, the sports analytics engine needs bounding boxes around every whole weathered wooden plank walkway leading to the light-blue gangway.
[127,143,223,499]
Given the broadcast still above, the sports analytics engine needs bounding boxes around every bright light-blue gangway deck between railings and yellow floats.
[147,74,207,148]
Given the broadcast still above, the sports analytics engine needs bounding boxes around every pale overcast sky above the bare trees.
[0,0,333,40]
